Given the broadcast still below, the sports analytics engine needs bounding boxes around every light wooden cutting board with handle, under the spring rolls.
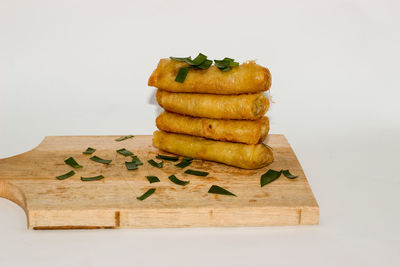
[0,135,319,230]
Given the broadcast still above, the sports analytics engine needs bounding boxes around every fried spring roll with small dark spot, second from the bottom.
[156,111,269,145]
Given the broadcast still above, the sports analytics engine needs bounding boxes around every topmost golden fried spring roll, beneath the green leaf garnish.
[148,59,271,95]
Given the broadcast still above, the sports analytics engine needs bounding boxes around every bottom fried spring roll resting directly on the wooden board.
[153,131,274,169]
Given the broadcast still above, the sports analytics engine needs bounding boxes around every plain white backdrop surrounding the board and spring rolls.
[0,0,400,266]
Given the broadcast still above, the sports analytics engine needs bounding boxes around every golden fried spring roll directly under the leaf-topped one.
[156,90,269,120]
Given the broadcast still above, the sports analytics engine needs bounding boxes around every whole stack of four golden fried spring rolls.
[148,59,273,169]
